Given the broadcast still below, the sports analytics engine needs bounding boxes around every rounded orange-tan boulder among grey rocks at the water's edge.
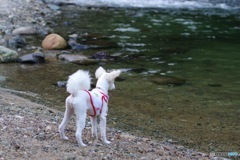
[42,33,67,50]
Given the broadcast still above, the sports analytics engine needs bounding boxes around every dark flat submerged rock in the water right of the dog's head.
[151,76,186,85]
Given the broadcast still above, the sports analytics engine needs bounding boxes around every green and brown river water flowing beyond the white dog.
[0,0,240,152]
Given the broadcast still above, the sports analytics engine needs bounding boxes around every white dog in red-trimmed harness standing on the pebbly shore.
[59,67,121,146]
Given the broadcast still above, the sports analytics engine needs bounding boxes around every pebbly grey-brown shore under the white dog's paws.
[0,88,216,160]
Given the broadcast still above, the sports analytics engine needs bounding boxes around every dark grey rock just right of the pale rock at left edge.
[18,52,45,64]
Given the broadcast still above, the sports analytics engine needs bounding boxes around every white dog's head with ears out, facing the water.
[95,67,121,90]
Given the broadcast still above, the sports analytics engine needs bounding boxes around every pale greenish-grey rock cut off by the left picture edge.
[0,46,18,63]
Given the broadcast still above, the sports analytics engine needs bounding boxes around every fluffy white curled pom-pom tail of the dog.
[67,70,91,95]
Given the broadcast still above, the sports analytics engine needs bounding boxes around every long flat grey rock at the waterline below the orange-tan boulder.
[58,54,98,65]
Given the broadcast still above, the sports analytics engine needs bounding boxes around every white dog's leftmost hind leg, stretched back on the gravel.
[58,97,74,140]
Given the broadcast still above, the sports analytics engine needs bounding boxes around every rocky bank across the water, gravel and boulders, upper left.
[0,0,103,65]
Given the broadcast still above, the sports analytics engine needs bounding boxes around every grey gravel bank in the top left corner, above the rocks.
[0,0,55,35]
